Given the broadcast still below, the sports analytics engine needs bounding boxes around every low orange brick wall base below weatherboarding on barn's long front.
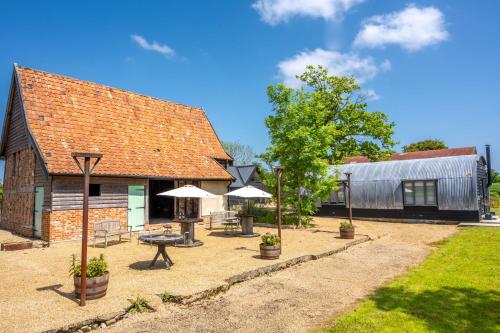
[46,208,128,241]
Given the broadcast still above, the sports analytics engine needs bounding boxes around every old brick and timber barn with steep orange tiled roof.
[0,66,233,241]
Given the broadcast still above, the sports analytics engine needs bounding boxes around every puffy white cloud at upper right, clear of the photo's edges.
[354,5,449,51]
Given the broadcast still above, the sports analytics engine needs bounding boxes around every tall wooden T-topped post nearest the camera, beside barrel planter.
[71,153,102,306]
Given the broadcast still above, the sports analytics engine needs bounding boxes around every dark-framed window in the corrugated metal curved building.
[403,180,437,206]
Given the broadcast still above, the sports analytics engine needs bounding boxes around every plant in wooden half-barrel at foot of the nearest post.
[69,253,109,299]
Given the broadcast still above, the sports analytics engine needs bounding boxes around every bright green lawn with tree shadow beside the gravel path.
[322,228,500,333]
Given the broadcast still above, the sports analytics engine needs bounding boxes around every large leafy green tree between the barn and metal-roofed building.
[261,66,395,226]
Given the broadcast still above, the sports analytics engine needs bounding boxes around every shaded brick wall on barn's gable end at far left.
[0,149,35,237]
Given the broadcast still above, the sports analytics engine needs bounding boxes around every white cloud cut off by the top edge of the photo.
[252,0,364,25]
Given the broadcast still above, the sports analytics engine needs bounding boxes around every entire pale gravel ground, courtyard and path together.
[0,218,456,332]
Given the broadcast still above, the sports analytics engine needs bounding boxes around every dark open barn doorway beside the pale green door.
[149,179,175,223]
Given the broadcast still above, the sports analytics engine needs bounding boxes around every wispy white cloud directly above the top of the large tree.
[278,48,390,88]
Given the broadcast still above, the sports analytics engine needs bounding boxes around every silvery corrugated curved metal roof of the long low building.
[331,155,482,210]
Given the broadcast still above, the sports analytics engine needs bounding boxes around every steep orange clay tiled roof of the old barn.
[16,66,232,179]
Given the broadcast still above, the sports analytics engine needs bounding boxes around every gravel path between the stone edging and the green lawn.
[107,223,456,332]
